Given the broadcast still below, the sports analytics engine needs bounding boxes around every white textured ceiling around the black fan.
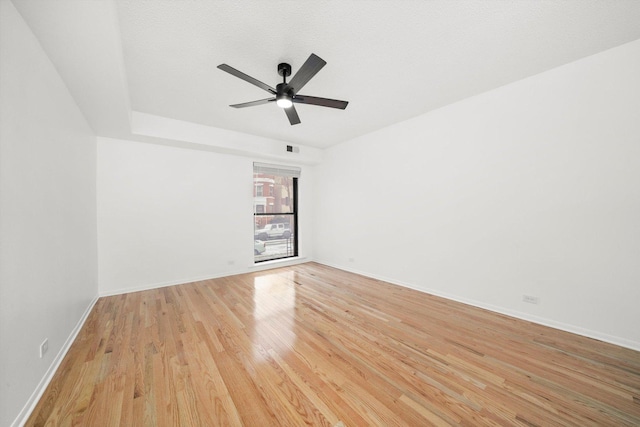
[8,0,640,148]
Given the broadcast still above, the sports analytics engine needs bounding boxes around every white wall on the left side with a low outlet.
[0,0,98,426]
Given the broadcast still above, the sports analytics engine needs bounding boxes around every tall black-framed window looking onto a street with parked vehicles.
[253,163,300,263]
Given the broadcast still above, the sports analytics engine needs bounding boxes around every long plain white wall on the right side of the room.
[314,41,640,349]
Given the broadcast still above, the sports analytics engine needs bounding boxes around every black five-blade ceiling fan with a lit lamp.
[218,53,348,125]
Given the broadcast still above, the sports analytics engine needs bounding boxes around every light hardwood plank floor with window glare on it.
[27,263,640,427]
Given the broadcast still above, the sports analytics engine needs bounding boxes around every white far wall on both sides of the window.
[97,138,313,295]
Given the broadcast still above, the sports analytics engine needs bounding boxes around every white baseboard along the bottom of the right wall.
[316,260,640,351]
